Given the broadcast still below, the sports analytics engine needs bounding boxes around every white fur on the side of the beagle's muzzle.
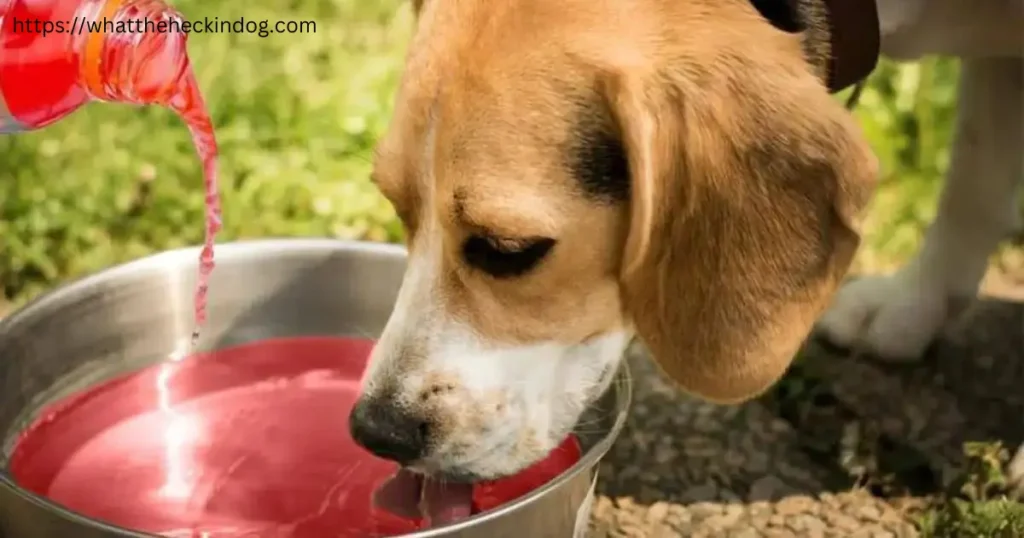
[403,324,631,475]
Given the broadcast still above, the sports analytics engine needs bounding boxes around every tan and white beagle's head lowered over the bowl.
[352,0,876,478]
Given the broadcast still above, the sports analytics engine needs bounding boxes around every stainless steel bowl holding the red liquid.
[0,240,630,538]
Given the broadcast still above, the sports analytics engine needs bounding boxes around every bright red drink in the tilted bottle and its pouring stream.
[0,0,220,340]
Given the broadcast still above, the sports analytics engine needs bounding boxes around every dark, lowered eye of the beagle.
[462,236,555,279]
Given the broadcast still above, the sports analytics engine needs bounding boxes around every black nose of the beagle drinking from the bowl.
[348,398,427,465]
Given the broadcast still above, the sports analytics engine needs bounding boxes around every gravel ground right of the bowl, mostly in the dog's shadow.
[590,278,1024,538]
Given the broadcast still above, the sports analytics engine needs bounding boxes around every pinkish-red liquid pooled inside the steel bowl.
[10,338,580,538]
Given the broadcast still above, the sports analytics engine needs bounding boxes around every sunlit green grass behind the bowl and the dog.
[0,0,955,303]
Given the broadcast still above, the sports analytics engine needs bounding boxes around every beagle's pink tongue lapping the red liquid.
[374,469,473,526]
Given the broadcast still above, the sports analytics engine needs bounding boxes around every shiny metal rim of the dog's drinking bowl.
[0,238,633,538]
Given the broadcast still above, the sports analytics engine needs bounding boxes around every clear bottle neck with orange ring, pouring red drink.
[76,0,188,105]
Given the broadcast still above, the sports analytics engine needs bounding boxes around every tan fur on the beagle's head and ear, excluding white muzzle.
[375,0,877,402]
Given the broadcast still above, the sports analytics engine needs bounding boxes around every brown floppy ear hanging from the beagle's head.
[606,54,877,403]
